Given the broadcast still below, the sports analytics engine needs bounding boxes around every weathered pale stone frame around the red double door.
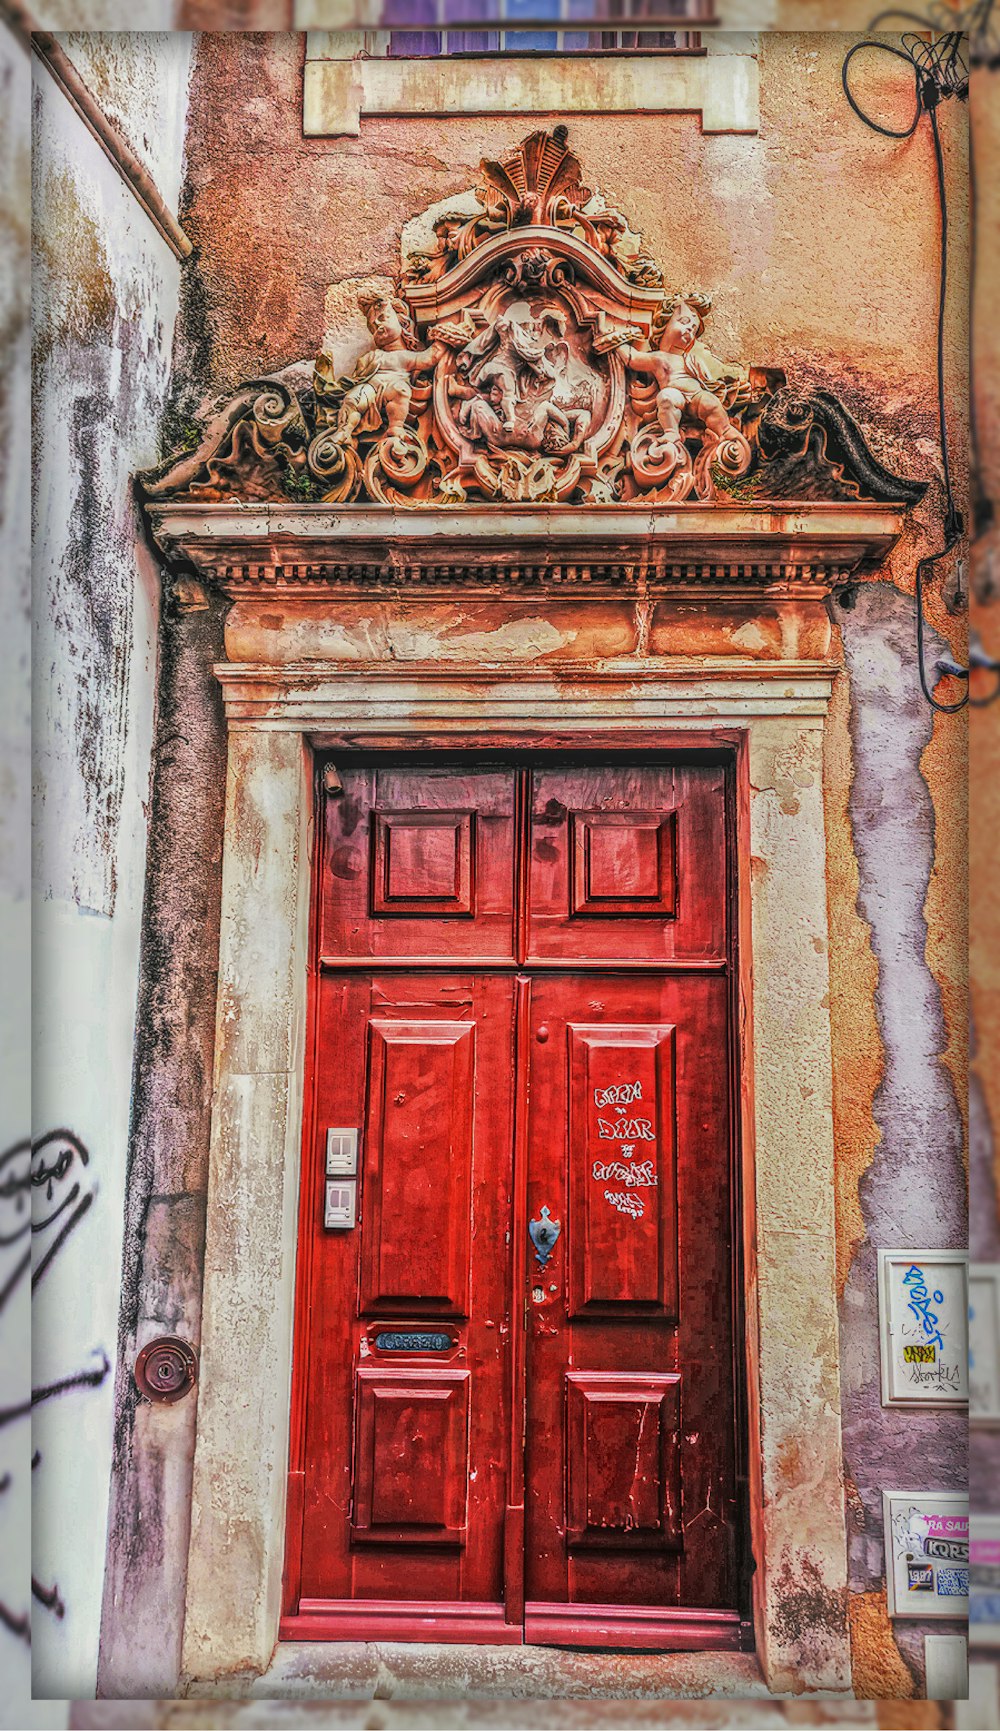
[182,660,851,1693]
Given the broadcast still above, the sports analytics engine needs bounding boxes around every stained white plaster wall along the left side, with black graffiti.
[33,36,190,1696]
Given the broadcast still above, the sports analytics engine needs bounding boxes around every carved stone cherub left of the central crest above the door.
[313,293,469,457]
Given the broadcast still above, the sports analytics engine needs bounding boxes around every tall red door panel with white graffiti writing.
[566,1023,676,1319]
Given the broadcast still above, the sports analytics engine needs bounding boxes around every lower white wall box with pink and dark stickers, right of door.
[882,1490,969,1618]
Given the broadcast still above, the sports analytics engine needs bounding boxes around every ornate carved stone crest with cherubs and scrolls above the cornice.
[142,126,924,507]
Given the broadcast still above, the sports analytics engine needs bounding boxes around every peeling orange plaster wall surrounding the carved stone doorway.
[79,36,967,1712]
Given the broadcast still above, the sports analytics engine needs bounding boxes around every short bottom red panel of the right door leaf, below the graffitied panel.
[566,1371,682,1551]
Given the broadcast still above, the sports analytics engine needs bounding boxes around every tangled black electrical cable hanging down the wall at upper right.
[841,27,971,715]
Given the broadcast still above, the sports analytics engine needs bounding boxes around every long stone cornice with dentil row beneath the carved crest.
[147,502,903,599]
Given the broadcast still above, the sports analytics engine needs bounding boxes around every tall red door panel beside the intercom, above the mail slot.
[360,1018,476,1316]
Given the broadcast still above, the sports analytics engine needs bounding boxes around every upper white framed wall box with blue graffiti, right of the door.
[879,1250,969,1406]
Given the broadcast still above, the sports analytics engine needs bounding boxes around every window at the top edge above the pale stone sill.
[381,0,698,59]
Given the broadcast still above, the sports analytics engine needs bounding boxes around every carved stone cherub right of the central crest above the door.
[593,294,746,466]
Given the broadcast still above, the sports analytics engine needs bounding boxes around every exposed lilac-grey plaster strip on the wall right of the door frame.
[841,583,967,1683]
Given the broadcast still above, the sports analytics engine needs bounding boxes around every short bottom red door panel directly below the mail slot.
[351,1366,469,1544]
